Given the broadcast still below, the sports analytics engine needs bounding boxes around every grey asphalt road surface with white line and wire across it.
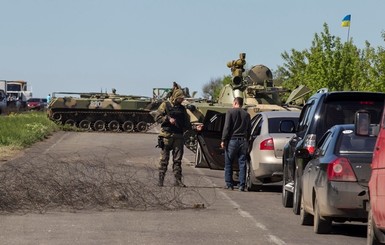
[0,132,366,245]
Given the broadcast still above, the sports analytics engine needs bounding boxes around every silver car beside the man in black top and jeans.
[246,111,300,191]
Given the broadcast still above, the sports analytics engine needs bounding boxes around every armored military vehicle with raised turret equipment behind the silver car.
[185,53,310,166]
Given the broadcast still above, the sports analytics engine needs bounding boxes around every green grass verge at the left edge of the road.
[0,112,60,149]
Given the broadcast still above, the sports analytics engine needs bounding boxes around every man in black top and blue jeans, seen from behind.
[221,97,251,191]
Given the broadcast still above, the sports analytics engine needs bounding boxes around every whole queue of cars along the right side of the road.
[196,89,385,244]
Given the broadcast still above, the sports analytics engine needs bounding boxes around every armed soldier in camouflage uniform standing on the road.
[156,89,191,186]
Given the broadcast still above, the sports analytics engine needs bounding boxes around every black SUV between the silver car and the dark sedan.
[282,89,385,214]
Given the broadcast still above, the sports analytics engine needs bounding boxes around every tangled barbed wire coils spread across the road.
[0,154,215,213]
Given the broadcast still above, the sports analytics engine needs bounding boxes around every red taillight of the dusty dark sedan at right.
[327,157,357,182]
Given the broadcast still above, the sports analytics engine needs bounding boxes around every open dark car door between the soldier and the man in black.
[197,110,230,170]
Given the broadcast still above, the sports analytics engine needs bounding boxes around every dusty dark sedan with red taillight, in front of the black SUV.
[296,124,377,234]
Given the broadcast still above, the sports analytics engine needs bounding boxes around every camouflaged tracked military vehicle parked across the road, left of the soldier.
[47,89,155,132]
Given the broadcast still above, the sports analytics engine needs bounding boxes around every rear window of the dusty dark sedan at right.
[337,130,376,154]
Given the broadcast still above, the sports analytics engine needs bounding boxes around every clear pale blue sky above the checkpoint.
[0,0,385,98]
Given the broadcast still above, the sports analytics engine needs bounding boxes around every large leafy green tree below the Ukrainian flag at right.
[276,23,385,92]
